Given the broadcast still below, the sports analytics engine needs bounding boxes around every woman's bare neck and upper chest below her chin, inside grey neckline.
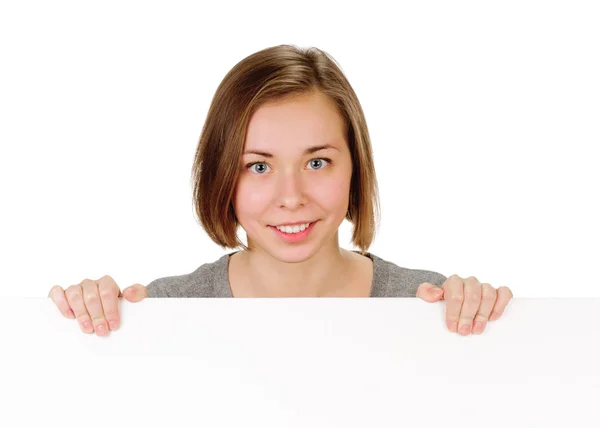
[240,245,350,297]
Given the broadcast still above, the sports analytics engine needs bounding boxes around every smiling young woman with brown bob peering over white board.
[49,45,513,335]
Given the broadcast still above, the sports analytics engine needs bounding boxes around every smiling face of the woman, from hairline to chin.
[234,92,352,262]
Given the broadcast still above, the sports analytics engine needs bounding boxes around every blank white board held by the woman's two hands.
[0,298,600,428]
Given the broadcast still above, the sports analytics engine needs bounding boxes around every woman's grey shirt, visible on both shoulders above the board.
[146,251,447,297]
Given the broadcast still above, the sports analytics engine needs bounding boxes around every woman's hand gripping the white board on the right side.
[417,275,513,336]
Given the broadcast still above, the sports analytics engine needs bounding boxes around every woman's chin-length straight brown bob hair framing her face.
[191,45,380,255]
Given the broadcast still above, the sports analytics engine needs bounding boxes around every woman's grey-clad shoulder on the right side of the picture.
[371,254,447,297]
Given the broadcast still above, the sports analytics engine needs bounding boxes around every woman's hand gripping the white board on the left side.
[48,275,147,336]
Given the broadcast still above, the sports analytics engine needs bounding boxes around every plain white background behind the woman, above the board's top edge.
[0,0,600,297]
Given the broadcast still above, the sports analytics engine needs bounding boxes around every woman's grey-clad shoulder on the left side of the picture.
[146,254,229,297]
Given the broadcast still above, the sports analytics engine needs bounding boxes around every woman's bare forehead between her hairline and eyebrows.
[245,92,345,148]
